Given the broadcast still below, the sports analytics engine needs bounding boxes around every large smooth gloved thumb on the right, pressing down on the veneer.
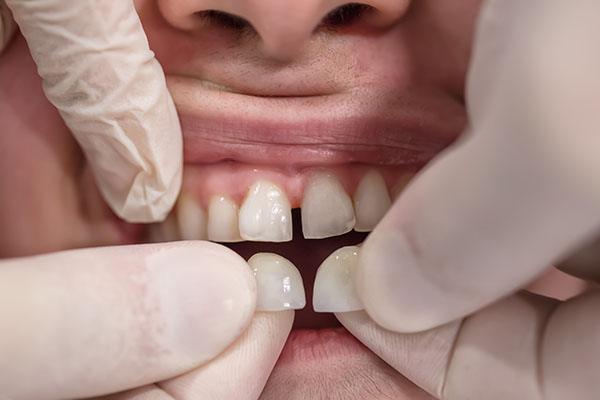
[356,0,600,332]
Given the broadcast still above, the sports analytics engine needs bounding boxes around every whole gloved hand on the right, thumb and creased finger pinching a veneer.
[338,0,600,399]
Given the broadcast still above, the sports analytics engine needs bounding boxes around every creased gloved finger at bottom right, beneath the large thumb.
[336,292,600,400]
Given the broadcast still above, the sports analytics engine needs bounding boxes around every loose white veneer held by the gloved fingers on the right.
[313,246,363,312]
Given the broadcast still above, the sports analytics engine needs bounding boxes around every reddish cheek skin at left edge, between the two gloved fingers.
[0,35,107,257]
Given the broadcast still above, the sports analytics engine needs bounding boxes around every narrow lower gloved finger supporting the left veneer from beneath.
[158,310,294,400]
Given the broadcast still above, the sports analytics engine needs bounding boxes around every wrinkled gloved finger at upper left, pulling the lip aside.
[6,0,183,222]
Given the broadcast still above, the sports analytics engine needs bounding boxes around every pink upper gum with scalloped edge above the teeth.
[182,161,417,209]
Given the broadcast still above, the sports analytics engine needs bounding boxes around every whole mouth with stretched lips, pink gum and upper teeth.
[143,77,464,396]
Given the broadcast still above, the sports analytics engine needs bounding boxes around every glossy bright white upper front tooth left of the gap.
[239,181,292,242]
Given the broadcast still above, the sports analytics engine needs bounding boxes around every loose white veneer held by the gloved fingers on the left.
[248,253,306,311]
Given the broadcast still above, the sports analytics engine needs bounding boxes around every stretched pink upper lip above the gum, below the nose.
[168,76,466,166]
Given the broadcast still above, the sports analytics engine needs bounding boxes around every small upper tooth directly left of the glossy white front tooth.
[207,196,242,242]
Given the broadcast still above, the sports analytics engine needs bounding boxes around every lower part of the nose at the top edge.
[158,0,411,59]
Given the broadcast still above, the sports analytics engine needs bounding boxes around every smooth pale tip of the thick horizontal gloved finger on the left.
[145,242,256,365]
